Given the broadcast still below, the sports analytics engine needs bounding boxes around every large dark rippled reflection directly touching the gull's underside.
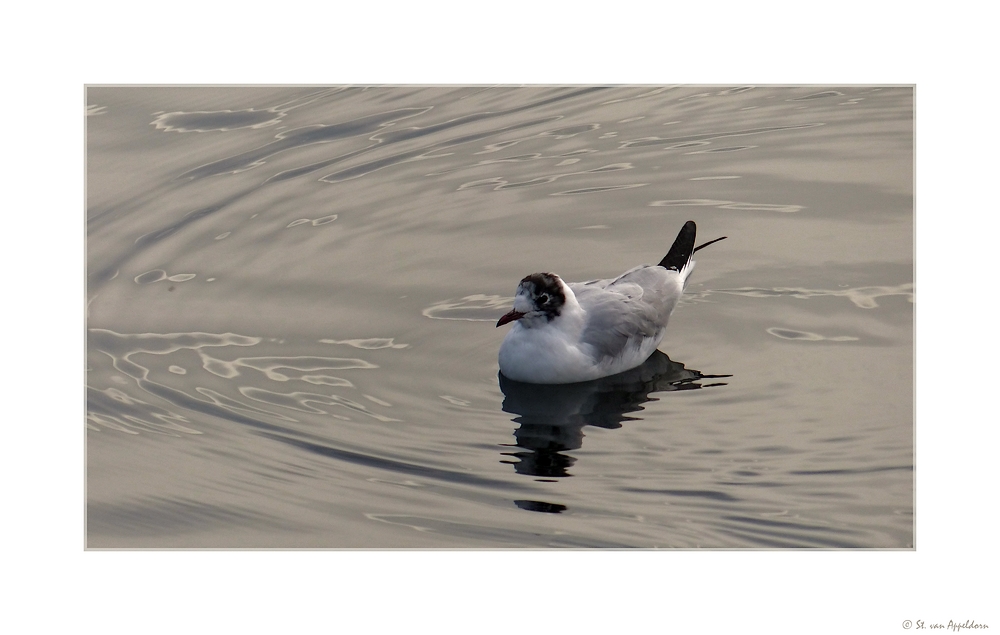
[500,351,731,478]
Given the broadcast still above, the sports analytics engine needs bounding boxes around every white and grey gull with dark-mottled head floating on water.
[497,221,725,384]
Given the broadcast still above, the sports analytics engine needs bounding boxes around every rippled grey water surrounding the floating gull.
[86,86,914,548]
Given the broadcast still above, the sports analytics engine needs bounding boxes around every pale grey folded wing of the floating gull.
[570,266,683,359]
